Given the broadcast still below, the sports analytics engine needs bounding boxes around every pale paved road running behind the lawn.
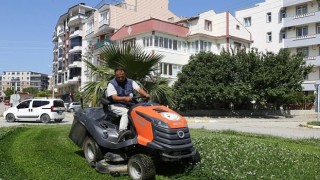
[0,103,320,139]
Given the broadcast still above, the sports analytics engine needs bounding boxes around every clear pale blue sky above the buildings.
[0,0,264,75]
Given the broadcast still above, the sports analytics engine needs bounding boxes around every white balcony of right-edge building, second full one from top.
[283,34,320,48]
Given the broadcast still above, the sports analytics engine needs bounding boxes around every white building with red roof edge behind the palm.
[111,10,252,85]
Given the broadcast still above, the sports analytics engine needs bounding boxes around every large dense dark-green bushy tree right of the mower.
[174,49,312,110]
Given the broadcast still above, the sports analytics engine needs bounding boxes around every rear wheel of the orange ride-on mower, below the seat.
[82,137,103,166]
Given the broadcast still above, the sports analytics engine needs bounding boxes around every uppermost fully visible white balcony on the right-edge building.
[282,11,320,27]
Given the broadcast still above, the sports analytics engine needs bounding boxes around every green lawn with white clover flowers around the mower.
[0,125,320,180]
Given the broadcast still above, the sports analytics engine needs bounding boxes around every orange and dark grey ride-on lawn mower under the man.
[69,99,201,179]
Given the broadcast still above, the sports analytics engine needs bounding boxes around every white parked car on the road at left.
[3,99,66,123]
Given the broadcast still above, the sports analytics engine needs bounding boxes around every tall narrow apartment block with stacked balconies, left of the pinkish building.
[52,3,95,95]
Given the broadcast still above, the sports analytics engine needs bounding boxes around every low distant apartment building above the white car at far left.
[1,71,48,95]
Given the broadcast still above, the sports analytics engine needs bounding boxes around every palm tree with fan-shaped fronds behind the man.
[82,45,173,106]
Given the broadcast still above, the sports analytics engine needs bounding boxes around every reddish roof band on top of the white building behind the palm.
[111,18,189,41]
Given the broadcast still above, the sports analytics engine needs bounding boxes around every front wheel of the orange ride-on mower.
[128,154,156,180]
